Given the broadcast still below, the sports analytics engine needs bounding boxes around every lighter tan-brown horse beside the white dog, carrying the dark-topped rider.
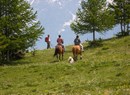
[72,45,82,61]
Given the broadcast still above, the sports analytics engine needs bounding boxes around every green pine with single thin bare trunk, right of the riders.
[71,0,114,41]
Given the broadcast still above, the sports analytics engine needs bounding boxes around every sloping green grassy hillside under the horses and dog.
[0,36,130,95]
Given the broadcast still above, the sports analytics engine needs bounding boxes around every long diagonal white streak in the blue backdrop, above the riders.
[58,12,76,34]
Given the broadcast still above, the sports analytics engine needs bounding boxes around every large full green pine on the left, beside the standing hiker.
[0,0,44,61]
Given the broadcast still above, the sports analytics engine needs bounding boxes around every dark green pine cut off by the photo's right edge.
[110,0,130,36]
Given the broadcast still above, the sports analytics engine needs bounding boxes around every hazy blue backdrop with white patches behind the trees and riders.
[26,0,119,50]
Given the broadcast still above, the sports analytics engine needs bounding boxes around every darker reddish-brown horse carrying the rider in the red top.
[54,45,64,60]
